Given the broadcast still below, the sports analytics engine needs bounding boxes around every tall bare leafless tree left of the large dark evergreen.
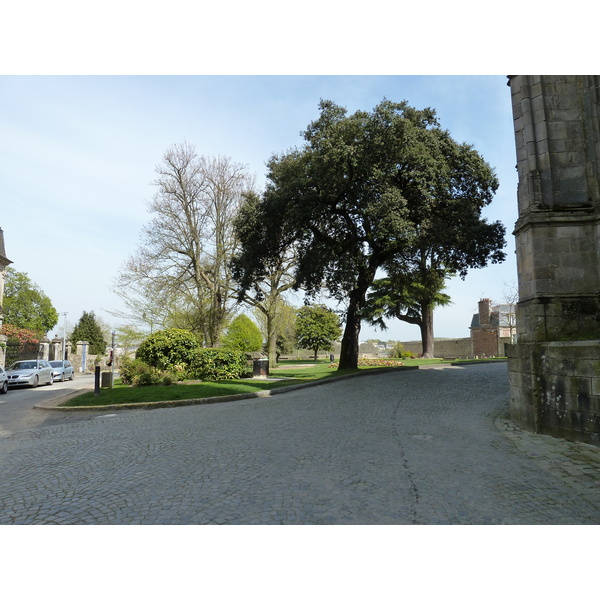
[116,143,254,346]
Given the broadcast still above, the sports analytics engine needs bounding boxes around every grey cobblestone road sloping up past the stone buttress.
[0,364,600,524]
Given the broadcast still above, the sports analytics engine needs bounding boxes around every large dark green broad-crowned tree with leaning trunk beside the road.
[236,100,504,369]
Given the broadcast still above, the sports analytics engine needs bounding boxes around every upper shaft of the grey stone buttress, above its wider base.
[510,75,600,342]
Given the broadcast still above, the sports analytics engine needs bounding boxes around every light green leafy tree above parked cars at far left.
[2,267,58,338]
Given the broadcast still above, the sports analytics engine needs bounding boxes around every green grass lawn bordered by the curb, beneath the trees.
[62,358,502,407]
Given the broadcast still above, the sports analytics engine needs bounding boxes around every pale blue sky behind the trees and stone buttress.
[0,75,517,341]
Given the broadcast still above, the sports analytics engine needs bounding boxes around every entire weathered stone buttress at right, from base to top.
[509,75,600,444]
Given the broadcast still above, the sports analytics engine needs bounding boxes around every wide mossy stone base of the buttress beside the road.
[507,340,600,445]
